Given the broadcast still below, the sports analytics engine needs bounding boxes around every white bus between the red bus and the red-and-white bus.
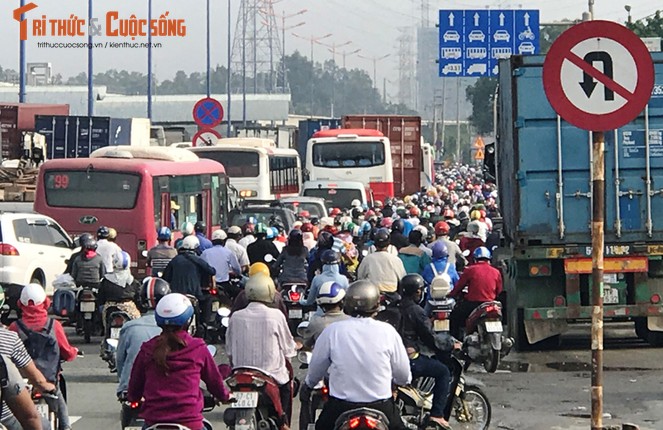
[189,137,302,200]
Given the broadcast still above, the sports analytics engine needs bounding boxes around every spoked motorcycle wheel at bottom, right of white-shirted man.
[449,386,492,430]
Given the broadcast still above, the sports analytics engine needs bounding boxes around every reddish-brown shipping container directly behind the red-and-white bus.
[343,115,422,196]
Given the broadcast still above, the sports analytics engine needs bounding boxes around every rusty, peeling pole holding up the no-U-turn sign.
[591,131,605,430]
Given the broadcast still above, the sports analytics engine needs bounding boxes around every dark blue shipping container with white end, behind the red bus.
[35,115,150,160]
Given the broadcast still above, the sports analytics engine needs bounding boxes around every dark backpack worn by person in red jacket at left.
[16,318,60,382]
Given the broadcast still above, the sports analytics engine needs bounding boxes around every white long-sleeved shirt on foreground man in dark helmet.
[306,318,412,403]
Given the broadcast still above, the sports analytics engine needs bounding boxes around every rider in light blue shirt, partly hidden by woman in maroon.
[115,276,170,398]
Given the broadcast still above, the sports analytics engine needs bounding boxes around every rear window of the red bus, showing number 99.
[44,170,140,209]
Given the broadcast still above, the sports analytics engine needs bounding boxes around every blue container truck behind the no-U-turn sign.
[486,53,663,349]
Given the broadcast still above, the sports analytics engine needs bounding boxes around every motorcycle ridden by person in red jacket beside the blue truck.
[463,301,513,373]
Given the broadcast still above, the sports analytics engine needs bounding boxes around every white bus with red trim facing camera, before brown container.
[306,129,394,201]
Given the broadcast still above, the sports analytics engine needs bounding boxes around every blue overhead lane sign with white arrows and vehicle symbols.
[439,9,539,77]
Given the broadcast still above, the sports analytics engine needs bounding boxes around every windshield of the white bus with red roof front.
[313,142,384,168]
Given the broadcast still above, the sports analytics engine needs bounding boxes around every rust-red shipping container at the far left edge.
[0,103,69,160]
